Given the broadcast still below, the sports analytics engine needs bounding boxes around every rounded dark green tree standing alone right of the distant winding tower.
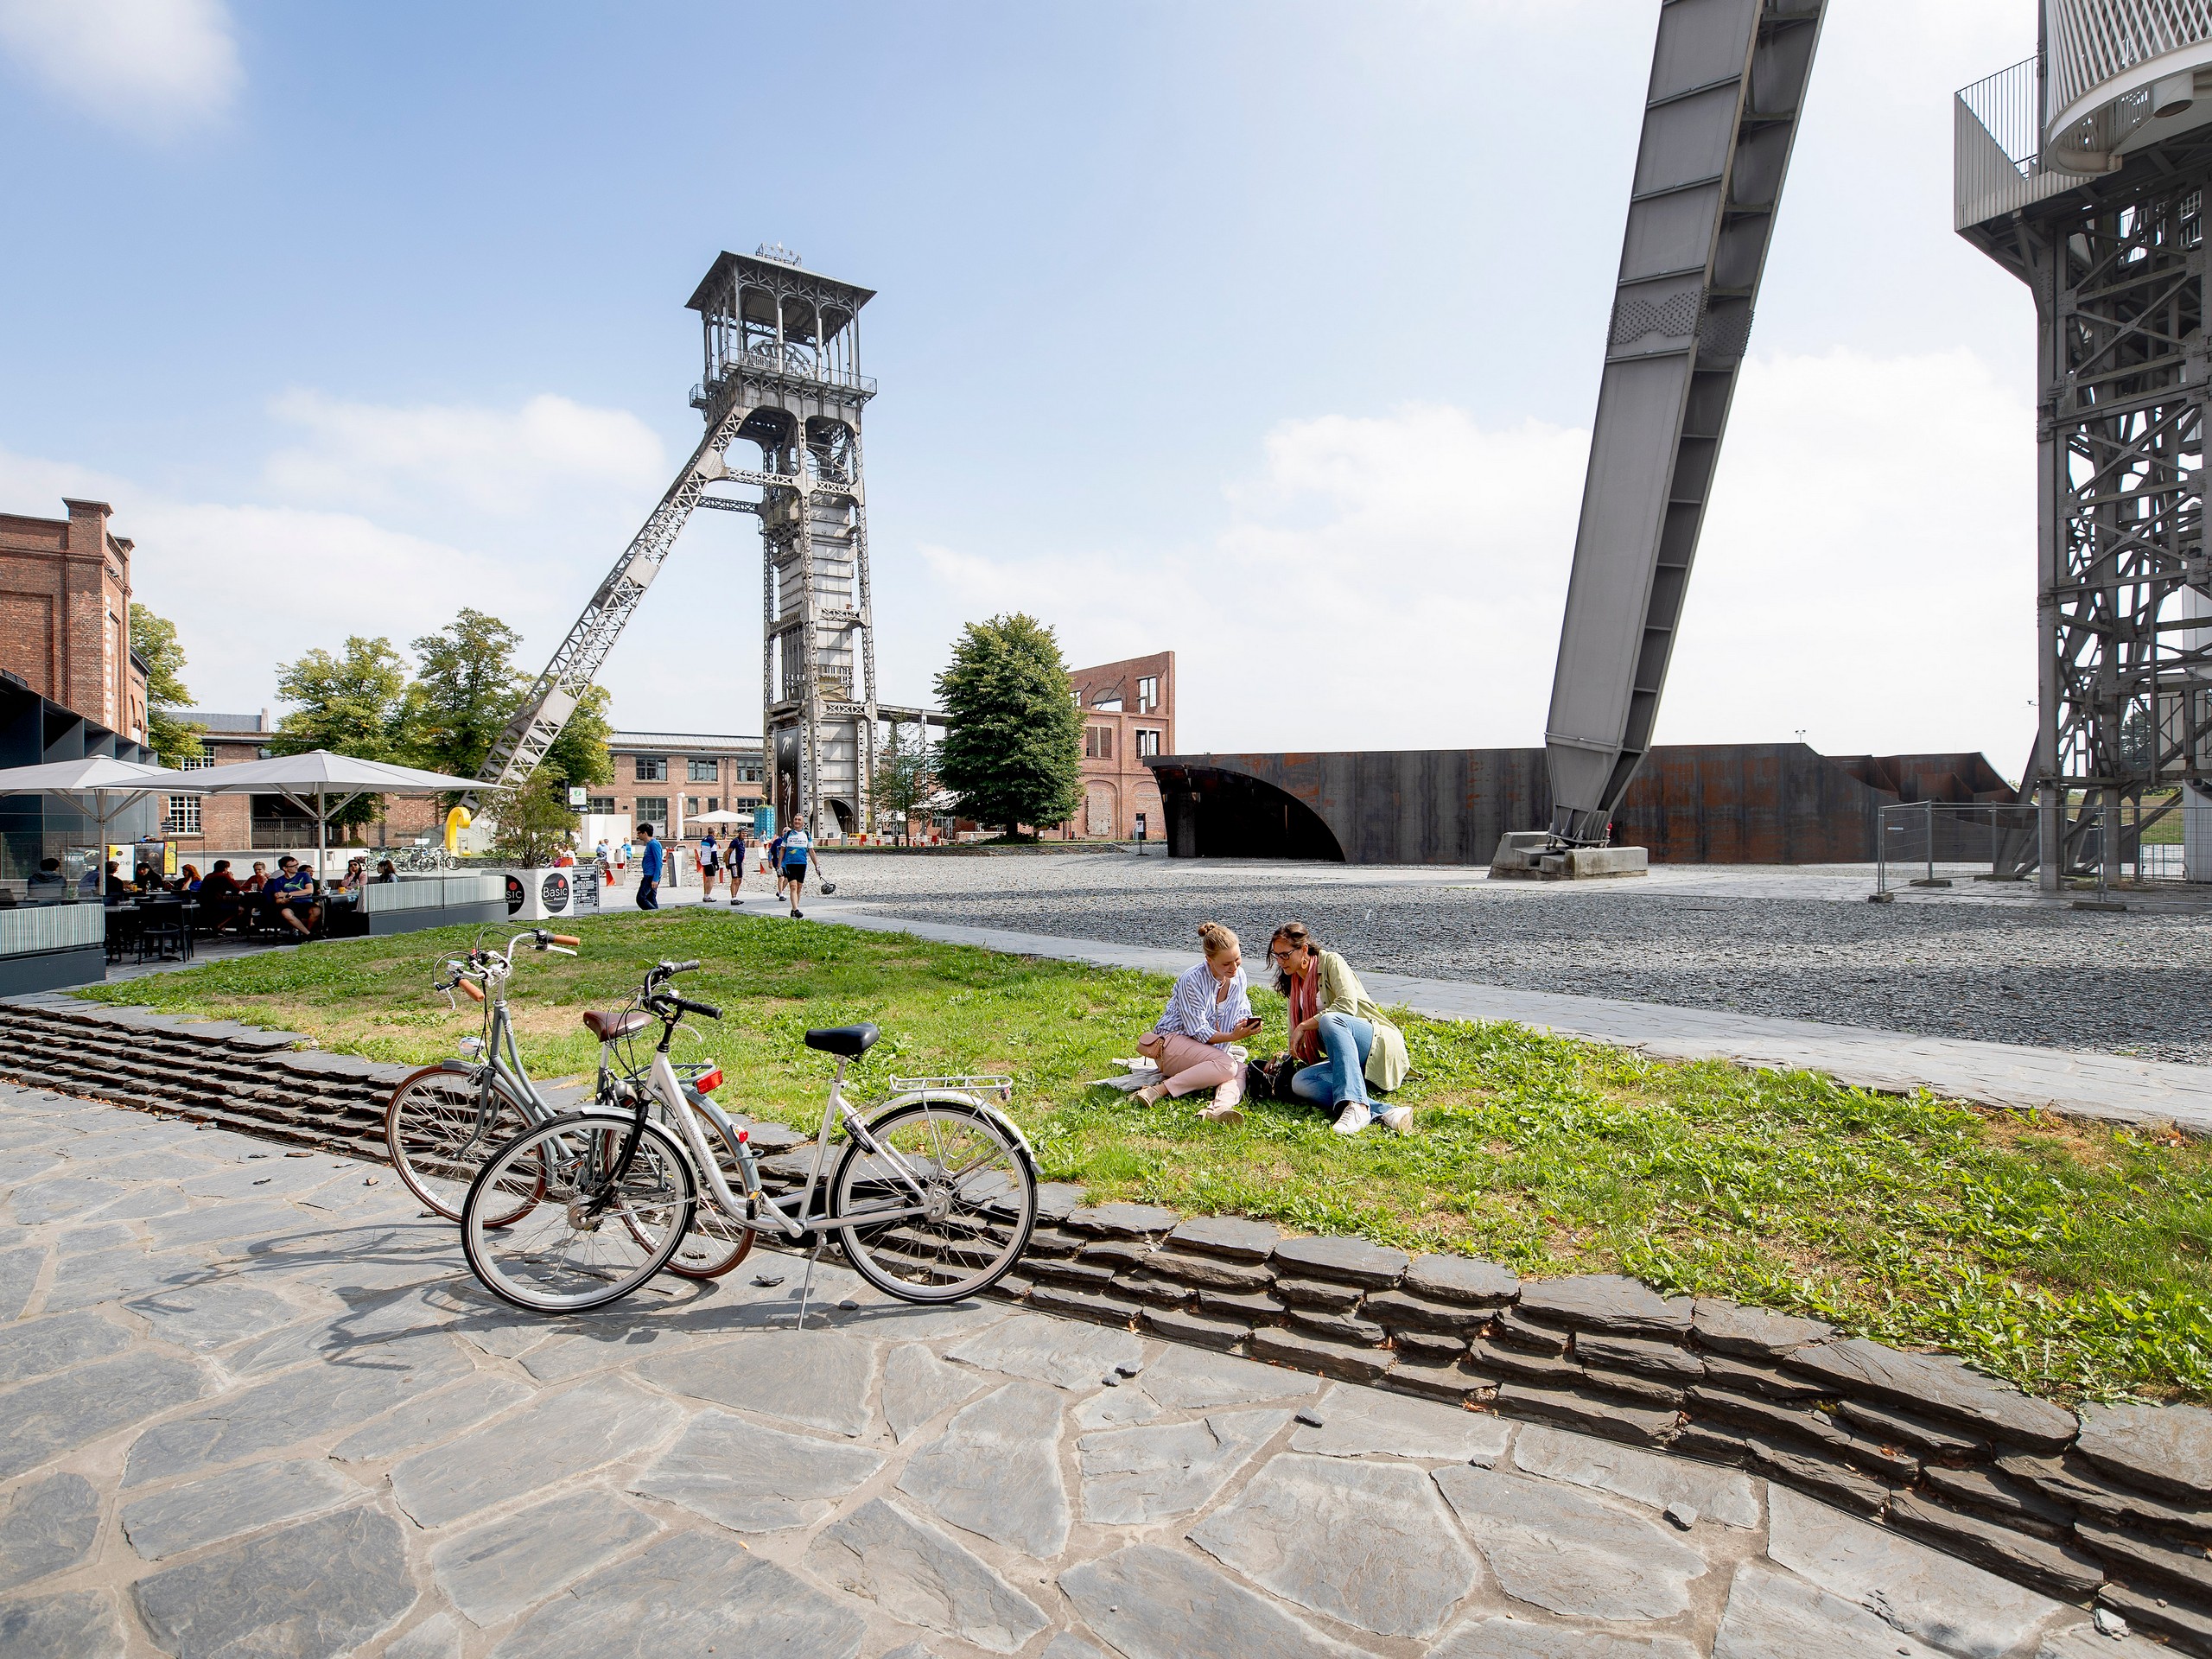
[938,615,1084,832]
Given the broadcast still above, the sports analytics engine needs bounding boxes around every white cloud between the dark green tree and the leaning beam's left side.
[925,407,1588,750]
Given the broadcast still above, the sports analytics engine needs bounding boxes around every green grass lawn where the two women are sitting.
[86,909,2212,1400]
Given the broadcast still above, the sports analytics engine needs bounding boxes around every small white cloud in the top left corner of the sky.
[0,0,245,135]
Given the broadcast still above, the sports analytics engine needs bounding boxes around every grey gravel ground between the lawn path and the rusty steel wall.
[800,852,2212,1064]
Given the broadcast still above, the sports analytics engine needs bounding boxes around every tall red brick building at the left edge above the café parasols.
[0,500,146,743]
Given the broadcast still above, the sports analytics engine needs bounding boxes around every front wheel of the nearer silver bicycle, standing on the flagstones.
[460,1113,695,1314]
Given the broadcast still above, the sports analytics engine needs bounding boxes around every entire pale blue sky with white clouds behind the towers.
[0,0,2033,772]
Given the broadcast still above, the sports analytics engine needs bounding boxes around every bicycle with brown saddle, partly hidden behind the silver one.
[385,927,752,1279]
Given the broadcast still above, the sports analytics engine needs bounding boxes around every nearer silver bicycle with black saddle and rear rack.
[460,963,1038,1325]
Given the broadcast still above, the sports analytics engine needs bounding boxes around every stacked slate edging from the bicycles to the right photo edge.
[1007,1185,2212,1655]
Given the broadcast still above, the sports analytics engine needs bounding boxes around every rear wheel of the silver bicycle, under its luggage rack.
[830,1099,1038,1303]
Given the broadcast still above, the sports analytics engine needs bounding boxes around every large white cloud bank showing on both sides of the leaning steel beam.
[923,352,2035,772]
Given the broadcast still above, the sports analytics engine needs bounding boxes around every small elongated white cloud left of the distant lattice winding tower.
[264,391,668,519]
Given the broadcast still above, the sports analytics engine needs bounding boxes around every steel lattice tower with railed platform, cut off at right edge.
[1953,0,2212,892]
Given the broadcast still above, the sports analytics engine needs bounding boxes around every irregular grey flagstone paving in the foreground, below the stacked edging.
[0,1089,2152,1659]
